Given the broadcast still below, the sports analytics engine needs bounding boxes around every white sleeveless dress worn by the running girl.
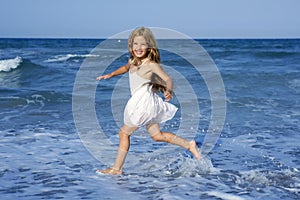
[124,68,178,127]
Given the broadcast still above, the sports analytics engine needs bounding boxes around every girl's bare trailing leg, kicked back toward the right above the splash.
[147,124,201,160]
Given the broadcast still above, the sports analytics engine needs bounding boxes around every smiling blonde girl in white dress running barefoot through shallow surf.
[97,27,200,174]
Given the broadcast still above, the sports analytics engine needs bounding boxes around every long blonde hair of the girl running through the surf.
[128,27,160,66]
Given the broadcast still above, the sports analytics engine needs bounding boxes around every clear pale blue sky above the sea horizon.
[0,0,300,39]
